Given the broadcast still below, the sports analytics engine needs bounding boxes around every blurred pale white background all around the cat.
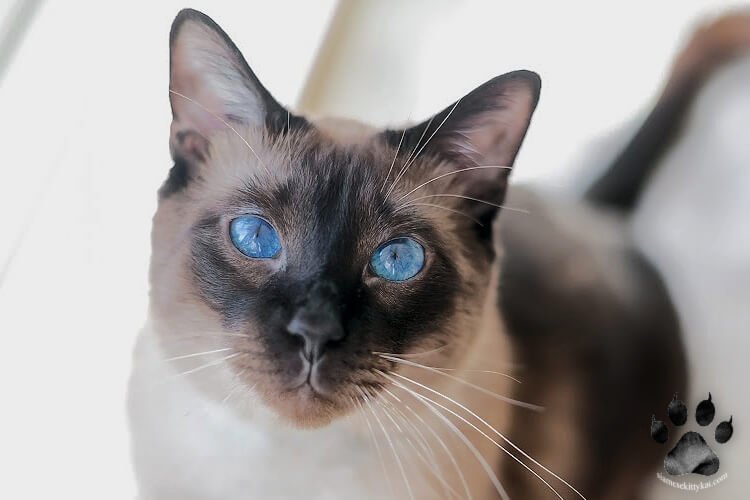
[0,0,750,499]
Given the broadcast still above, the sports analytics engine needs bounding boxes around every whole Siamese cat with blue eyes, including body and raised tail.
[129,10,749,500]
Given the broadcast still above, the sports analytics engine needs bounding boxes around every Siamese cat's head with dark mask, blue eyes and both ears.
[151,10,539,426]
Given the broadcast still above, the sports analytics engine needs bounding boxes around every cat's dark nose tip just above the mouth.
[286,307,344,361]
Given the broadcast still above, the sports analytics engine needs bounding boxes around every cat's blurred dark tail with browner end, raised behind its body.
[584,10,750,212]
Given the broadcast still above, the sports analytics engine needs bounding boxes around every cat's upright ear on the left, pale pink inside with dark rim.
[169,9,301,161]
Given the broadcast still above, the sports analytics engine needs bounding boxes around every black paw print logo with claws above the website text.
[651,392,734,476]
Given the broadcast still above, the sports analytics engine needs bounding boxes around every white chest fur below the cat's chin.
[129,326,394,500]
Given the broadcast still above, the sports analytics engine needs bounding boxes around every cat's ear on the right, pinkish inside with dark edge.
[385,71,541,222]
